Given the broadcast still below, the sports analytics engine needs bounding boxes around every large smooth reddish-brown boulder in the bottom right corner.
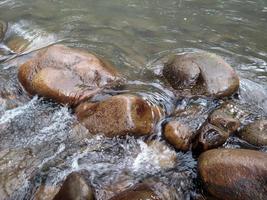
[198,149,267,200]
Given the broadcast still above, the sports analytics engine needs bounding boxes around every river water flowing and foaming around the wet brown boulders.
[0,0,267,200]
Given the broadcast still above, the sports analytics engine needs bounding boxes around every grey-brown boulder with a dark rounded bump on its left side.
[163,51,239,97]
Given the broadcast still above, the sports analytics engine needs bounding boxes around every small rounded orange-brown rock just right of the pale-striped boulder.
[164,121,193,151]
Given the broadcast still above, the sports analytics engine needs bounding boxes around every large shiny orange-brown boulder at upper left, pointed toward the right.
[18,45,119,104]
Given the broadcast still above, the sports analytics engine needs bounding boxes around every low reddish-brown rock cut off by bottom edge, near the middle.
[110,184,160,200]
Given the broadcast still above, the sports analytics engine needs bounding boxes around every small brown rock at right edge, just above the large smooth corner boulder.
[238,120,267,146]
